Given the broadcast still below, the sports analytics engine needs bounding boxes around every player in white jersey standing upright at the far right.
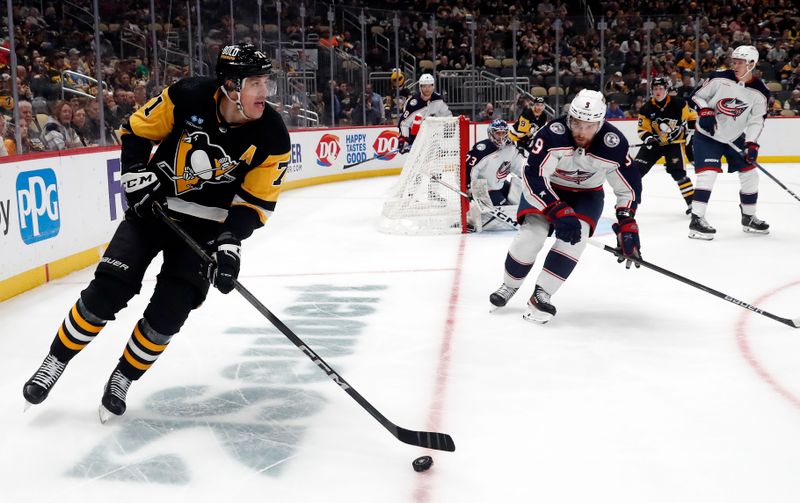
[689,45,769,240]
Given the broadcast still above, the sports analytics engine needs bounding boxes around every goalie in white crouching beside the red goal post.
[466,119,527,232]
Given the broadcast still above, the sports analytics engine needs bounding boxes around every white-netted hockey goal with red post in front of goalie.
[380,116,469,234]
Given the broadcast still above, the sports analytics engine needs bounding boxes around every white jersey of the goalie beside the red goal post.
[466,140,525,190]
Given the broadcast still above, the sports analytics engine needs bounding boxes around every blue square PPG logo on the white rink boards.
[17,169,61,244]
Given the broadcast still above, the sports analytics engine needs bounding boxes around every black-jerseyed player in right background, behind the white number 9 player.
[633,77,697,215]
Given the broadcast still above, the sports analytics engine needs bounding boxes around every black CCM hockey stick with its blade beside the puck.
[156,206,456,452]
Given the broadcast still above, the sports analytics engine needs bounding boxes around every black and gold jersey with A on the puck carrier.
[120,77,291,239]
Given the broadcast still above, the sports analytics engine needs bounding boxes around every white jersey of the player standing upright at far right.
[690,70,769,143]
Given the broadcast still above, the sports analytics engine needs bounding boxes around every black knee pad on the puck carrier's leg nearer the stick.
[144,276,208,335]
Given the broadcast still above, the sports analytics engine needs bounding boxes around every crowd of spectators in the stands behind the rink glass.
[0,0,800,155]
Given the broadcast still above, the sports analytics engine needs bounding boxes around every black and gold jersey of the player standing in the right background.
[637,95,697,144]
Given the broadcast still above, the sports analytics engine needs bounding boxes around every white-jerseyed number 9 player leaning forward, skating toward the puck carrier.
[489,90,641,323]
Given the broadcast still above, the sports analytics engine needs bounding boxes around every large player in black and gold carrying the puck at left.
[23,45,291,422]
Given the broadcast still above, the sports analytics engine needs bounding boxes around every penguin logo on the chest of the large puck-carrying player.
[158,131,239,195]
